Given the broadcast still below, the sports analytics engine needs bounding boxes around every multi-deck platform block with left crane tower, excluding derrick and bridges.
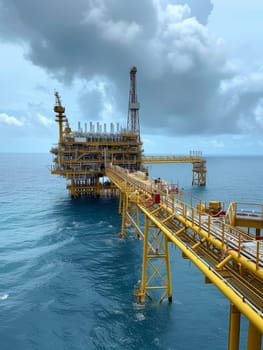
[51,92,142,197]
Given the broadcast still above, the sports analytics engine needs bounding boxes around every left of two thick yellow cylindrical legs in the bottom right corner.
[228,304,240,350]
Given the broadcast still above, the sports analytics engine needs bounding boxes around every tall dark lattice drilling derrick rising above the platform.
[127,67,140,139]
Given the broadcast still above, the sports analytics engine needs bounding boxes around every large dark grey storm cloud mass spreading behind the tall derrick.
[0,0,261,134]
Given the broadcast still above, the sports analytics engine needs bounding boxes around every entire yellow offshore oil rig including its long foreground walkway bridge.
[51,67,263,350]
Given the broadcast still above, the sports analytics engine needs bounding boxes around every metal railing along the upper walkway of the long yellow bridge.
[106,166,263,279]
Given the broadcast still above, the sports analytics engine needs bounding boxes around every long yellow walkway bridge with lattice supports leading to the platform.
[106,165,263,350]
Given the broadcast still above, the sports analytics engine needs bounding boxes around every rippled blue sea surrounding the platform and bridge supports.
[0,153,263,350]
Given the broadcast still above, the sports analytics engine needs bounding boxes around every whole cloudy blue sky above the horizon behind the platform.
[0,0,263,155]
